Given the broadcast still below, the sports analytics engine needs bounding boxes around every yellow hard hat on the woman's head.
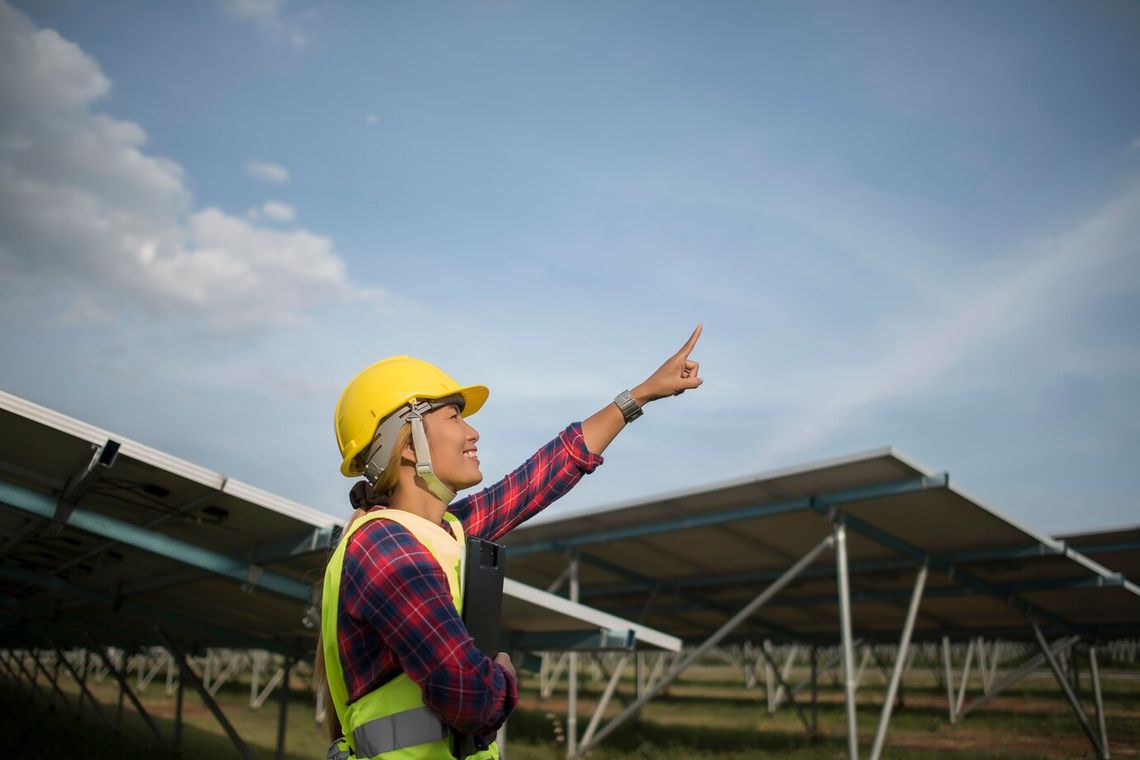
[334,357,490,477]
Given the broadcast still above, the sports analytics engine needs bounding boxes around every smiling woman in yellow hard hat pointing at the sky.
[318,325,702,760]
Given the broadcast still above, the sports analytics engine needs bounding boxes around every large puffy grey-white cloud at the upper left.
[0,0,360,330]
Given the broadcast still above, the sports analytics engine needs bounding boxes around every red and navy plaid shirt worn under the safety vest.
[336,423,602,735]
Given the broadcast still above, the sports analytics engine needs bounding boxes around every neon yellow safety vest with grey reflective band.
[320,509,499,760]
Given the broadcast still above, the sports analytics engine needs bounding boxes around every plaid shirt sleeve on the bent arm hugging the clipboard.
[337,520,518,735]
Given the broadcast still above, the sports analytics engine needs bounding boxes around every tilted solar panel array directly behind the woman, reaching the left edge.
[0,392,679,657]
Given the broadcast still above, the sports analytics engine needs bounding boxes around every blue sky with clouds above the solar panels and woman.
[0,0,1140,531]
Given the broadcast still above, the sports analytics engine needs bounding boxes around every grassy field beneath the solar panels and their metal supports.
[0,662,1140,760]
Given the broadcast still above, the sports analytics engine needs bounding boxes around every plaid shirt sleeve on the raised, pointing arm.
[448,423,603,541]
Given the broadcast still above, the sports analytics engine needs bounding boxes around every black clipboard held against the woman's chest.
[455,536,506,758]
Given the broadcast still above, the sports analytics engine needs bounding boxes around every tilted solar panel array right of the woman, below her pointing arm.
[507,449,1140,643]
